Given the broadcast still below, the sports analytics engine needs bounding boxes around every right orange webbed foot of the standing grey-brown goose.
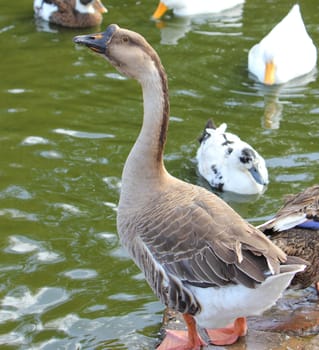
[206,317,247,345]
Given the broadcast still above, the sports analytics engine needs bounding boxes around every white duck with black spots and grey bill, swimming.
[196,119,269,195]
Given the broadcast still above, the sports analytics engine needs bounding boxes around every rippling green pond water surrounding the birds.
[0,0,319,349]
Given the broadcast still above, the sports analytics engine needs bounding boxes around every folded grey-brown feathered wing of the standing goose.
[139,185,286,287]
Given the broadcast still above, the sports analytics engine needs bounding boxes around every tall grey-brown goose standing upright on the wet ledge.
[73,24,305,350]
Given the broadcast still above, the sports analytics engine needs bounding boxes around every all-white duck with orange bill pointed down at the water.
[248,4,317,85]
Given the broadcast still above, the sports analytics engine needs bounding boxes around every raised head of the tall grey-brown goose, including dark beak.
[73,24,159,82]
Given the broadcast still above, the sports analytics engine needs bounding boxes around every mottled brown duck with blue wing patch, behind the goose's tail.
[258,185,319,294]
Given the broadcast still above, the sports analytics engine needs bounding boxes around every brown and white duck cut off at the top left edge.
[33,0,107,28]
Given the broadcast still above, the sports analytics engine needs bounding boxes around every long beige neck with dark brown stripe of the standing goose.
[120,59,169,206]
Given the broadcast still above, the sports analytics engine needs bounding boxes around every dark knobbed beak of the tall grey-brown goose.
[73,24,118,54]
